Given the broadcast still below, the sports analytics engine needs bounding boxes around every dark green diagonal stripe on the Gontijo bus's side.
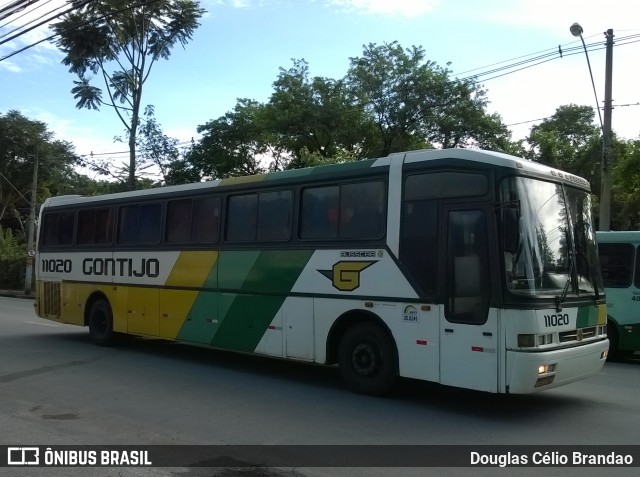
[212,250,313,352]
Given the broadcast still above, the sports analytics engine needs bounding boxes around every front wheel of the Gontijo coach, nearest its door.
[338,323,398,396]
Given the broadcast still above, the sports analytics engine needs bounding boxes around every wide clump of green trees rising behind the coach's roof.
[174,42,523,178]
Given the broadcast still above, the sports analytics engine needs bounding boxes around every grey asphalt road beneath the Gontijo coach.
[0,298,640,477]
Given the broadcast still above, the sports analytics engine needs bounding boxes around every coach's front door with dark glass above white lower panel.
[440,205,500,392]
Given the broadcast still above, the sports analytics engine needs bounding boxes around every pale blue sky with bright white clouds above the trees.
[0,0,640,171]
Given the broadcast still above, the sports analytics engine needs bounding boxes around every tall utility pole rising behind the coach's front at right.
[598,29,613,230]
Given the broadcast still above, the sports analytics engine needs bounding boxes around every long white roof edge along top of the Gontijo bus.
[44,148,589,206]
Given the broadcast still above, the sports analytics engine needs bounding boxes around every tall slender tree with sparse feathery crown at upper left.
[53,0,204,189]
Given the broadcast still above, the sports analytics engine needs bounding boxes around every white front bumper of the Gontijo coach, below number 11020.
[506,340,609,394]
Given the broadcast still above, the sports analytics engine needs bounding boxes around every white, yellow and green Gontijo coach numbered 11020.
[35,149,609,395]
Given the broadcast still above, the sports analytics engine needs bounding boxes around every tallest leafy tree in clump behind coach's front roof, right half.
[346,42,514,157]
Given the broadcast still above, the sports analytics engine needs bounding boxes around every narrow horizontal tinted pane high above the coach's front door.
[404,172,489,200]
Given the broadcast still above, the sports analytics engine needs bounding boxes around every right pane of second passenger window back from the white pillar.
[258,190,293,241]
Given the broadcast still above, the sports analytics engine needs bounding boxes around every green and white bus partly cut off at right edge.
[596,231,640,357]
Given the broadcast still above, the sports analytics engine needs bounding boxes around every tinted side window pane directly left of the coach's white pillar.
[339,182,384,239]
